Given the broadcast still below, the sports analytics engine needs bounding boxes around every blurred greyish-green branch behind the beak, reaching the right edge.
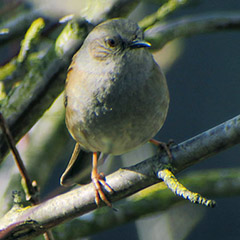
[145,12,240,49]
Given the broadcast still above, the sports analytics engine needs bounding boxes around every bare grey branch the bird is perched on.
[0,115,240,239]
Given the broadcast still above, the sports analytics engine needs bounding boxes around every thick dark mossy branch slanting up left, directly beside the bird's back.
[0,22,87,161]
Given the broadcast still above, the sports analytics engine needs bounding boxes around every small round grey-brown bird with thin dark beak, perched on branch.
[61,19,169,206]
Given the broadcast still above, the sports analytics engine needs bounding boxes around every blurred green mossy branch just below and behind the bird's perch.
[54,168,240,240]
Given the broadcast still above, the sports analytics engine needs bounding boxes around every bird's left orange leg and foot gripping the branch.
[91,152,113,207]
